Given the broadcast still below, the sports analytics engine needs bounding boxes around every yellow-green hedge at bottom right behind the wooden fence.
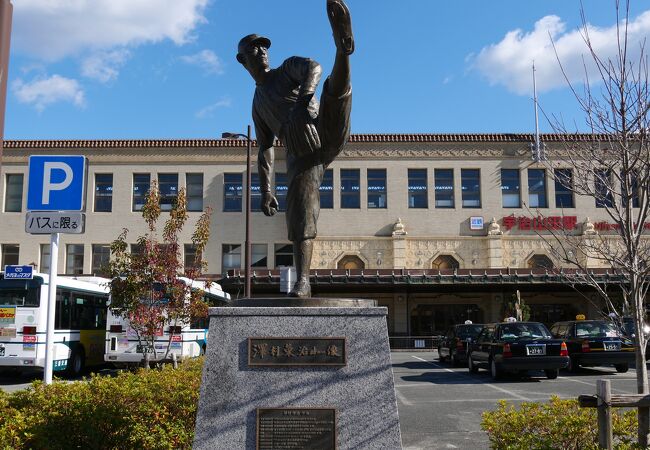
[481,396,638,450]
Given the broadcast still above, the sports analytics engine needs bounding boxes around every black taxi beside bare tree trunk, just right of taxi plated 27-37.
[551,320,635,373]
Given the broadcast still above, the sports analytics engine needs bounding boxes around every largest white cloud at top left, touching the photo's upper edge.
[12,0,209,61]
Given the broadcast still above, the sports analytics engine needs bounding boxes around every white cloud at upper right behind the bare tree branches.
[470,11,650,95]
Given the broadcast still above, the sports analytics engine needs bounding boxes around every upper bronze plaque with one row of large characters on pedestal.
[248,337,347,367]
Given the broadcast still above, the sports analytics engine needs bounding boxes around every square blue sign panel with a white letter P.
[27,155,86,211]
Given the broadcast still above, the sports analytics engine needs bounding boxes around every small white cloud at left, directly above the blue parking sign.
[12,75,85,112]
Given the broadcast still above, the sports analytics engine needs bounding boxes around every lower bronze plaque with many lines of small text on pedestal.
[257,408,336,450]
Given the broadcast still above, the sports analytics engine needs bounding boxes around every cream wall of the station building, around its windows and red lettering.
[0,141,624,274]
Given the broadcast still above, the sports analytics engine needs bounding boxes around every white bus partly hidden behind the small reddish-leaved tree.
[104,277,230,366]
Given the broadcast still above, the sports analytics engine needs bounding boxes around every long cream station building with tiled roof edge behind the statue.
[0,134,624,336]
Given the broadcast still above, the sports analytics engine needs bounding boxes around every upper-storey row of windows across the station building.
[5,169,638,212]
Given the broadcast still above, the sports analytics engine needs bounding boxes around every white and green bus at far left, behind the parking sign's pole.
[0,272,109,376]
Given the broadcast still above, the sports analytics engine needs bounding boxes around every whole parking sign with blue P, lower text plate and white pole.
[25,155,86,384]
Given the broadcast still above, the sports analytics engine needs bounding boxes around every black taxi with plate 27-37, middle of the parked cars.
[467,321,569,379]
